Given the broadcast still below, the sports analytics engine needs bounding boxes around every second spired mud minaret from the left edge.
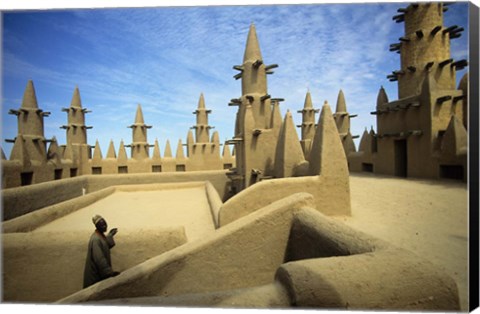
[61,86,92,145]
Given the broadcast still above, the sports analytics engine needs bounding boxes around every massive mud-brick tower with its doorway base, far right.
[350,2,468,180]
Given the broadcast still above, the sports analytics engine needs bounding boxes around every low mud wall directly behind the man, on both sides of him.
[2,227,187,303]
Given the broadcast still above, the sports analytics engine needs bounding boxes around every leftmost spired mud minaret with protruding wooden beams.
[8,80,50,162]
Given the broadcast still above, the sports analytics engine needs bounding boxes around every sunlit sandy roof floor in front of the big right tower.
[339,175,468,311]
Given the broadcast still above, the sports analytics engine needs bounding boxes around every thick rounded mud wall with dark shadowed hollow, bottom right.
[276,208,460,311]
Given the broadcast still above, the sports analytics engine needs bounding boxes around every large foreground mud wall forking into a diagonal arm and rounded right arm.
[57,193,460,311]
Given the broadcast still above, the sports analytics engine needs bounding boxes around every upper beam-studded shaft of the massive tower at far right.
[388,2,466,99]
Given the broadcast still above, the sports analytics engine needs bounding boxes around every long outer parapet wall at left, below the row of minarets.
[1,170,228,221]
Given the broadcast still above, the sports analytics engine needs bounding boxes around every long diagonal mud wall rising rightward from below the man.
[61,193,313,303]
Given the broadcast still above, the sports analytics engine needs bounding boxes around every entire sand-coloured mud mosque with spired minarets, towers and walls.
[2,2,468,311]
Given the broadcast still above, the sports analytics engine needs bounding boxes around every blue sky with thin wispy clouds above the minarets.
[0,3,468,158]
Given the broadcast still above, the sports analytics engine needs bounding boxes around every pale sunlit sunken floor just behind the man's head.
[34,186,215,242]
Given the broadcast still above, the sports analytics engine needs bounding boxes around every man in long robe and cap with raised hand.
[83,215,120,288]
